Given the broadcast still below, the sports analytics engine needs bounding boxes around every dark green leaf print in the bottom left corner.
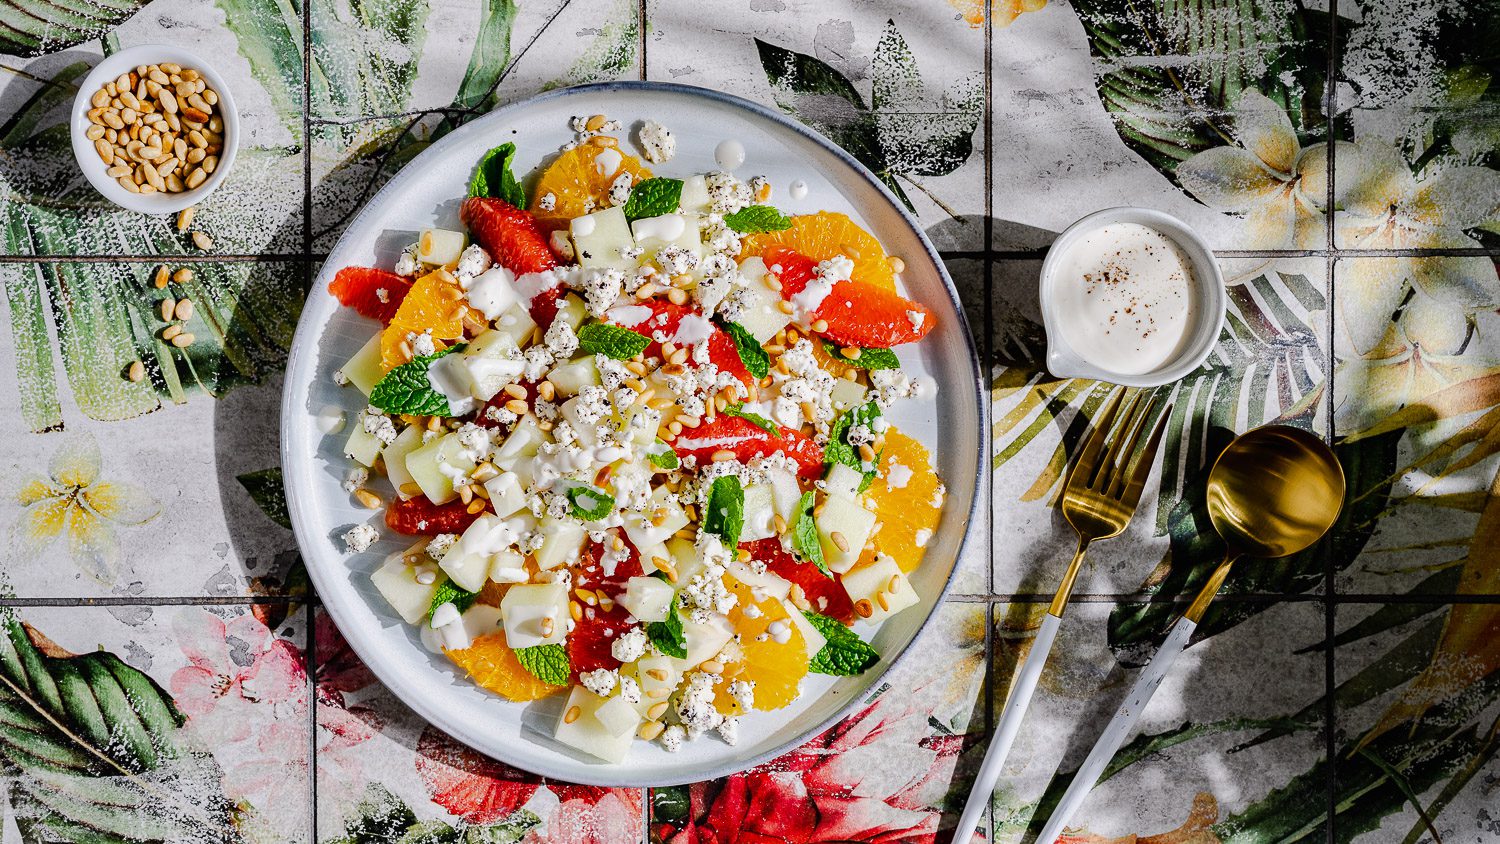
[0,613,233,843]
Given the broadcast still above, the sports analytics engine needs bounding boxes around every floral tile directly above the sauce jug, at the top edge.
[993,0,1329,249]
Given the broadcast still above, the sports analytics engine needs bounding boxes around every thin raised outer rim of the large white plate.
[278,79,990,787]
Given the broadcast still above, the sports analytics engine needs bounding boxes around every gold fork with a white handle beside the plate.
[953,390,1172,843]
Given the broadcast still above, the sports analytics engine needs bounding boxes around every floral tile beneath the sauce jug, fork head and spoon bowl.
[990,258,1328,595]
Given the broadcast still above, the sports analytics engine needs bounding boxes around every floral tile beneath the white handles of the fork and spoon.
[977,601,1328,844]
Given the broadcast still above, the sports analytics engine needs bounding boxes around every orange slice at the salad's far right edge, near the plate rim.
[861,427,944,573]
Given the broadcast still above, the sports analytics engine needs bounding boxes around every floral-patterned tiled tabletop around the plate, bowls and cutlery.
[0,0,1500,844]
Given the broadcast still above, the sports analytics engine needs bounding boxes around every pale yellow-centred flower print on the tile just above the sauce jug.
[1176,88,1358,249]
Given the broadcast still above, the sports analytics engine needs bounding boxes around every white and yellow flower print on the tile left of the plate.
[15,433,162,583]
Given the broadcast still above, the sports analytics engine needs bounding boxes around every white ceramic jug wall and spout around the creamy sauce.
[1041,207,1226,387]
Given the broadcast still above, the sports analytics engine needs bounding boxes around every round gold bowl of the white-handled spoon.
[1208,424,1344,558]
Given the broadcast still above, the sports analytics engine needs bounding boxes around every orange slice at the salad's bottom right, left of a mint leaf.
[714,574,807,715]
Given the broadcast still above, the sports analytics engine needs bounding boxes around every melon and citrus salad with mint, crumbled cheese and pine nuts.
[330,117,944,763]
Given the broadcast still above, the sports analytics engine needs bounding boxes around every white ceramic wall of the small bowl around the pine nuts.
[69,43,240,214]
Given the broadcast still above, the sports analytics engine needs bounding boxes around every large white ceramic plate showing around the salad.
[281,82,987,786]
